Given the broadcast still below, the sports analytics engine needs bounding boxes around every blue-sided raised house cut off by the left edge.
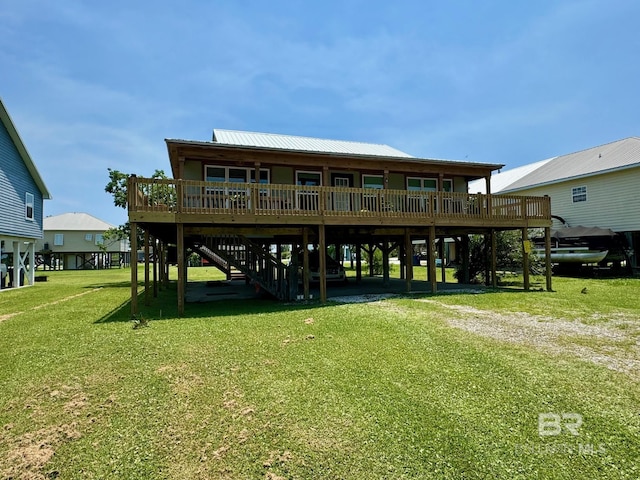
[0,100,51,288]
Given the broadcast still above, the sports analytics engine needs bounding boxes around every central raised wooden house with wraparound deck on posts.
[128,130,551,313]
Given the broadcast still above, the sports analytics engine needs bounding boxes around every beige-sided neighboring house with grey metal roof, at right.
[470,137,640,269]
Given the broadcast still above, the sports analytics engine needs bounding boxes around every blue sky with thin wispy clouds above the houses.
[0,0,640,224]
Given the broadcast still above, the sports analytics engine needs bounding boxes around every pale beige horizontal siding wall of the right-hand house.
[514,168,640,232]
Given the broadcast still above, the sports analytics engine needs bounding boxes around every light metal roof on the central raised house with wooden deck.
[213,129,414,158]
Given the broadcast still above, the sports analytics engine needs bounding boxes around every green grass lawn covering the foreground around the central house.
[0,268,640,479]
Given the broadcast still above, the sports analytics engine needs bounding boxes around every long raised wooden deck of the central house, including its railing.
[128,177,551,228]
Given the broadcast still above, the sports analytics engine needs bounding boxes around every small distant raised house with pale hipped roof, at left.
[38,213,129,270]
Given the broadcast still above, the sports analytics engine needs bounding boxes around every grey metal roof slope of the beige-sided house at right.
[501,137,640,192]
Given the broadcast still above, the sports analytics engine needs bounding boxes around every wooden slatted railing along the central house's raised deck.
[128,177,551,220]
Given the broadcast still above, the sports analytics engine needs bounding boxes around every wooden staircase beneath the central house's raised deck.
[193,235,297,300]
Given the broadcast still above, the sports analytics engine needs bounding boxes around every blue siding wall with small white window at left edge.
[0,123,43,238]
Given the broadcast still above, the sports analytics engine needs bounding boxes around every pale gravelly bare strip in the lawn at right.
[417,299,640,381]
